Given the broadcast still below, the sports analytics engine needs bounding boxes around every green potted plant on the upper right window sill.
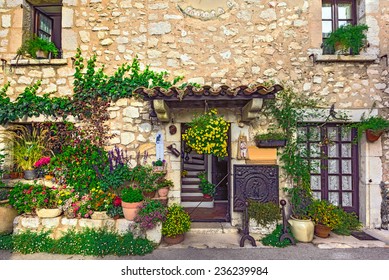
[324,24,369,55]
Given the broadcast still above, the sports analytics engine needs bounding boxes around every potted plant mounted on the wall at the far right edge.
[353,116,389,142]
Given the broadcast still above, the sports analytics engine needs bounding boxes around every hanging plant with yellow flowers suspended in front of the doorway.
[182,109,230,157]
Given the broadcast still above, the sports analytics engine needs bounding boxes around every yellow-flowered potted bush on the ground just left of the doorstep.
[162,204,191,244]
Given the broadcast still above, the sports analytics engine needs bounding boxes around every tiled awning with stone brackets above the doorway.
[134,84,283,122]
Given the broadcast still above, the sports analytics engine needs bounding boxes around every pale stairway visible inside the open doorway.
[181,152,214,208]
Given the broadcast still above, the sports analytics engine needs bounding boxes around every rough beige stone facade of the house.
[0,0,389,227]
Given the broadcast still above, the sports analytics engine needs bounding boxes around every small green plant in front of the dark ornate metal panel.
[248,199,281,227]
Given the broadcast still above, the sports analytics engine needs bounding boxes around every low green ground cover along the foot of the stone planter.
[7,228,154,256]
